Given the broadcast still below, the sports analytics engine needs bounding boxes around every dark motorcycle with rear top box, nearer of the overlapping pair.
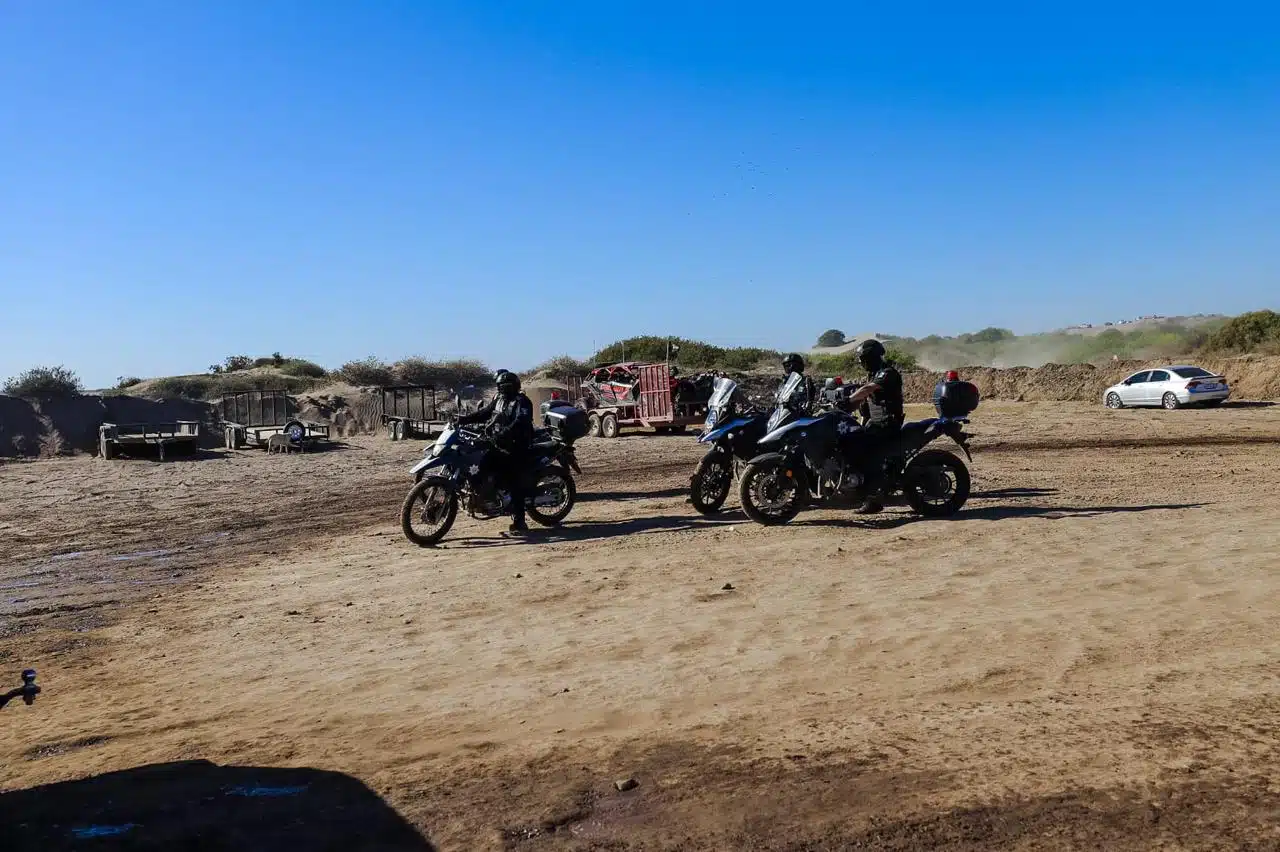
[739,394,975,526]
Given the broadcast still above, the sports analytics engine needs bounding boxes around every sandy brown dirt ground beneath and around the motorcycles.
[0,403,1280,852]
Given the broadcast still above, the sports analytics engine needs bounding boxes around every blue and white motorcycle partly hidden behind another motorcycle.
[689,374,809,514]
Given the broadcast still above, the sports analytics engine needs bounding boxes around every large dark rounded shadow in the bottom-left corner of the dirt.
[0,760,435,852]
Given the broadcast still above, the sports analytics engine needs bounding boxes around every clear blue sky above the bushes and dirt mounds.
[0,0,1280,386]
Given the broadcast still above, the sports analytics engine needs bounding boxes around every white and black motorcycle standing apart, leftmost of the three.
[401,414,585,548]
